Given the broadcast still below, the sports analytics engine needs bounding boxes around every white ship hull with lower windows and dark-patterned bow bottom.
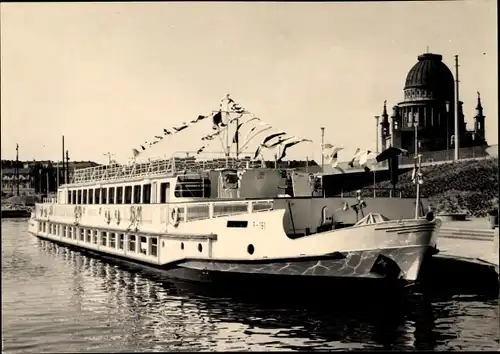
[30,198,440,282]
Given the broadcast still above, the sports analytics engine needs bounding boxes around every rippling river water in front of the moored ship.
[1,220,499,353]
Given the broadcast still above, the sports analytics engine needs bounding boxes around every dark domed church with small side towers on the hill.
[380,53,486,154]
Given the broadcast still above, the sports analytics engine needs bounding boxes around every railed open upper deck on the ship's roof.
[70,157,261,185]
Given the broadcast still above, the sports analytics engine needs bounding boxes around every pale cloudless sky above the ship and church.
[0,0,498,163]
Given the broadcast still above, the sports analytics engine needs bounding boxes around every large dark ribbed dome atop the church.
[404,53,454,100]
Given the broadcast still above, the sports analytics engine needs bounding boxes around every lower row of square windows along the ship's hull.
[38,222,158,257]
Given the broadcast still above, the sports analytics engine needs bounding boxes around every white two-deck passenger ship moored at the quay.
[29,97,440,283]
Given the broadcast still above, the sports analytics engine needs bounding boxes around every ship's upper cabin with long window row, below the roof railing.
[57,168,321,204]
